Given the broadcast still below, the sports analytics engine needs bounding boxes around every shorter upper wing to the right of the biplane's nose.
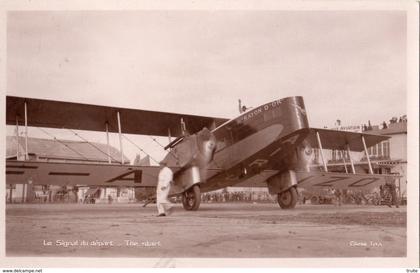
[302,128,390,152]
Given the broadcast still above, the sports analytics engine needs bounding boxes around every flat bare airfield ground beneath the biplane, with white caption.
[6,203,407,258]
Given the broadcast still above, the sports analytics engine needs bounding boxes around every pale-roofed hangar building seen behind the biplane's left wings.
[6,136,134,203]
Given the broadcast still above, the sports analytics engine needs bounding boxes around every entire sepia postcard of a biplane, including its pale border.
[2,0,419,267]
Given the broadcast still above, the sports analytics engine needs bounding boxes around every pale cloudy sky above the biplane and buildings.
[6,10,407,163]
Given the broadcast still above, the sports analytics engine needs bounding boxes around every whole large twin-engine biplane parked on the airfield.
[6,96,392,210]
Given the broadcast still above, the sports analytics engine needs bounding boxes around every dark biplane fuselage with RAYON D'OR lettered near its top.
[201,96,309,191]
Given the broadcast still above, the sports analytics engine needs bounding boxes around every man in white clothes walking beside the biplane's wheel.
[156,166,174,216]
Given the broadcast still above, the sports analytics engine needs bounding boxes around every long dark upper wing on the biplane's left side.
[6,96,227,136]
